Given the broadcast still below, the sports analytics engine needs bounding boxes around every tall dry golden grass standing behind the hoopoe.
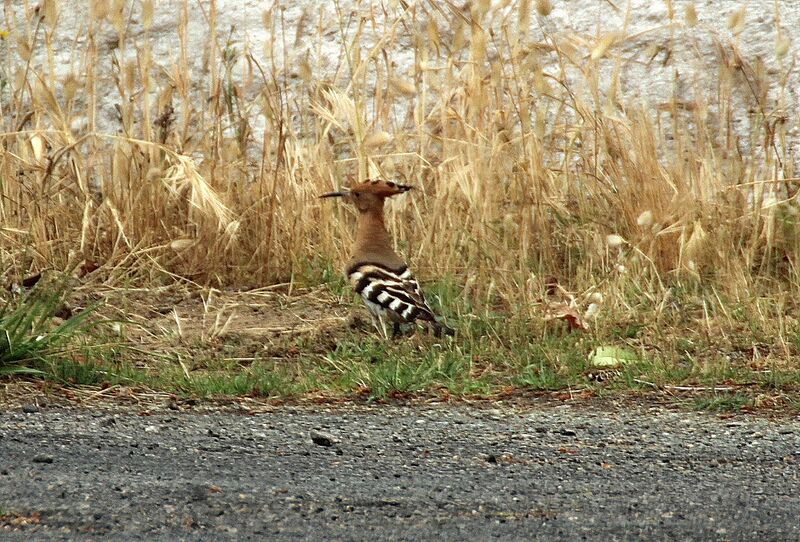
[0,0,800,366]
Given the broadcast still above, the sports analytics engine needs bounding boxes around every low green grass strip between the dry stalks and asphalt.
[9,278,800,411]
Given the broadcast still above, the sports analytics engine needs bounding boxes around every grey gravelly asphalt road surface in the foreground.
[0,406,800,541]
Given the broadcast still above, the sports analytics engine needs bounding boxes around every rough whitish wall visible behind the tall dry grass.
[4,0,800,140]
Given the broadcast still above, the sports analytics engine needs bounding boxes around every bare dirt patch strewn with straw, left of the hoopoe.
[90,286,359,362]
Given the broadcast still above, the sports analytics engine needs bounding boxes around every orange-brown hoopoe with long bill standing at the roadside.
[320,180,455,338]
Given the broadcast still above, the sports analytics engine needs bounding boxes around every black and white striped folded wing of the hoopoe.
[349,264,436,322]
